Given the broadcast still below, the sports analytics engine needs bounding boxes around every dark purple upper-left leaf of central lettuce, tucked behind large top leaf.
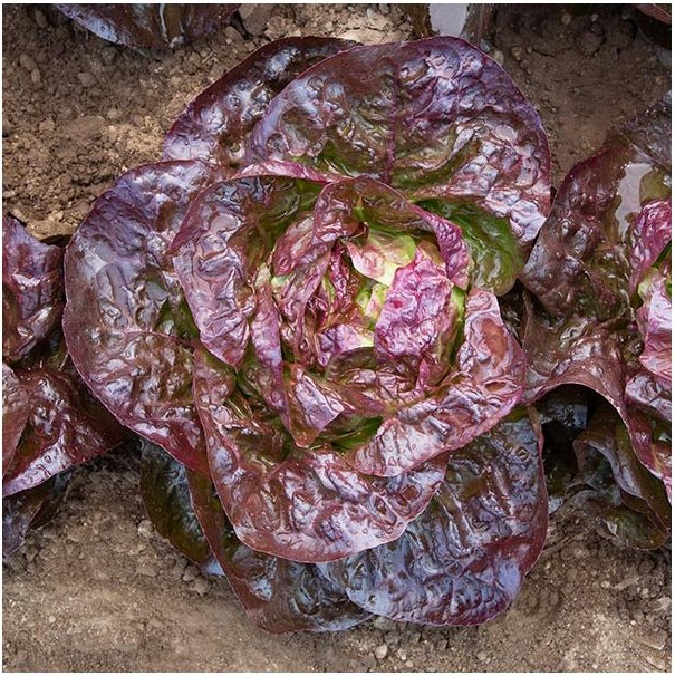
[164,37,356,167]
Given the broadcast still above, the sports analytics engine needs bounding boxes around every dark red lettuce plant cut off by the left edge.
[2,217,127,556]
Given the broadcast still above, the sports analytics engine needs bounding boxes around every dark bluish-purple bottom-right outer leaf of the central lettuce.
[320,409,548,626]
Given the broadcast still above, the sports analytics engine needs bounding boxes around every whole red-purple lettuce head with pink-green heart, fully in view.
[64,38,550,632]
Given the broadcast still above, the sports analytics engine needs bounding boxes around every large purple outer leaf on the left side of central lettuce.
[63,161,225,472]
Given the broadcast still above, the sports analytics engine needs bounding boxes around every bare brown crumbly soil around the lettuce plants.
[2,4,672,672]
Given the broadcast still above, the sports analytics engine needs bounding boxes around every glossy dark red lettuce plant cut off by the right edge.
[521,96,672,548]
